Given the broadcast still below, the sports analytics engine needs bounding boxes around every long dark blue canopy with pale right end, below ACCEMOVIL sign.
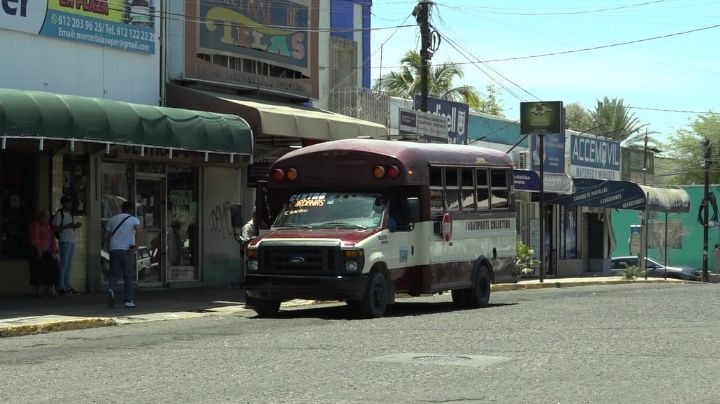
[547,178,690,212]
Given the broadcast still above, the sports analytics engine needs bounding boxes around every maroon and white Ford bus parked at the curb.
[245,139,517,318]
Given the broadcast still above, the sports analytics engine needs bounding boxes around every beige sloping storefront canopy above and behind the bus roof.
[167,84,387,143]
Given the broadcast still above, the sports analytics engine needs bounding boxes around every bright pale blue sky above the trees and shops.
[371,0,720,142]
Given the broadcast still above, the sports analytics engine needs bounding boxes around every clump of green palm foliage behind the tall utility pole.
[373,50,503,116]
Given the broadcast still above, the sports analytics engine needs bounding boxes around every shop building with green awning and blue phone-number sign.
[0,0,253,294]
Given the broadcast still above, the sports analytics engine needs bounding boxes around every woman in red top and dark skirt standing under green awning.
[28,209,60,297]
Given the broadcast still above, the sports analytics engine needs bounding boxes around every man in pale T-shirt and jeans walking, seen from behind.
[103,201,142,308]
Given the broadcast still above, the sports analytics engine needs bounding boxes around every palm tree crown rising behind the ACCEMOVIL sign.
[590,97,642,141]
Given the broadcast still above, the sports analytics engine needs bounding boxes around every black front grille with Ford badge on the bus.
[259,247,340,275]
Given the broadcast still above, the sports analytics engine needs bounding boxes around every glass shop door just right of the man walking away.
[135,176,165,285]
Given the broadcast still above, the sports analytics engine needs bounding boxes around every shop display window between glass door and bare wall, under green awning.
[167,166,200,281]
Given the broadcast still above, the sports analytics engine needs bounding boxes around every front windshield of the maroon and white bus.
[273,192,384,230]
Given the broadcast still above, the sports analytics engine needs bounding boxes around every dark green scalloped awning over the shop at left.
[0,89,253,155]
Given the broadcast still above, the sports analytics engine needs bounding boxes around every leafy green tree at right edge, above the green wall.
[656,114,720,184]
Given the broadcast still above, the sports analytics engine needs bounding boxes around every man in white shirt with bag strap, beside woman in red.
[52,195,80,295]
